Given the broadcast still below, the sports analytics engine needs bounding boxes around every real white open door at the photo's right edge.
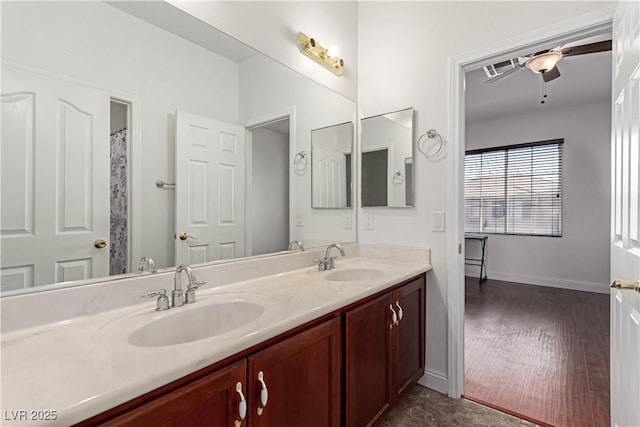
[611,0,640,426]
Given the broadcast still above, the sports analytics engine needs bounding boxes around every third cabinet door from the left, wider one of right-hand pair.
[345,294,392,427]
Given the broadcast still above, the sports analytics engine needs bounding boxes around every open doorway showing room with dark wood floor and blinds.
[464,32,611,425]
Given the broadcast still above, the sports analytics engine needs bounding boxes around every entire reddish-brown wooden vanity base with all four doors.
[84,275,426,427]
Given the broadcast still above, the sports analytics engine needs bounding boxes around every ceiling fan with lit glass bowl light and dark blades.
[485,40,611,83]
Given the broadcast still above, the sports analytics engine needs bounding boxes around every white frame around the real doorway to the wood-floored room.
[447,5,615,398]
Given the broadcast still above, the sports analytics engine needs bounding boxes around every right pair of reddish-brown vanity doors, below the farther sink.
[344,276,426,427]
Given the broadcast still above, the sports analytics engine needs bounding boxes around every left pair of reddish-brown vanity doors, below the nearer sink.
[97,317,342,427]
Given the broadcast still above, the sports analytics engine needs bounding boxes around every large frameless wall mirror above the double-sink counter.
[0,1,356,296]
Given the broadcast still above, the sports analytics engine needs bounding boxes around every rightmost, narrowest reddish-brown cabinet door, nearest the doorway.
[392,277,426,399]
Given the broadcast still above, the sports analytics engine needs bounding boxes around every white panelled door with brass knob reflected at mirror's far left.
[0,64,110,291]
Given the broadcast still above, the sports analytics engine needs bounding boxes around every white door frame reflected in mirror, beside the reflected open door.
[241,105,296,256]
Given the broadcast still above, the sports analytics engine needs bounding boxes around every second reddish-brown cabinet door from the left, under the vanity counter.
[247,318,342,427]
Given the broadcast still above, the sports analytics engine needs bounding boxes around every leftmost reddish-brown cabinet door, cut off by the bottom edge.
[104,360,247,427]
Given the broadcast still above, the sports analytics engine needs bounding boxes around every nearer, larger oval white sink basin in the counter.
[129,301,264,347]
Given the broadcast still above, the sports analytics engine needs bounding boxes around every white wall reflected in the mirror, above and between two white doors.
[2,2,238,266]
